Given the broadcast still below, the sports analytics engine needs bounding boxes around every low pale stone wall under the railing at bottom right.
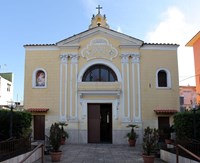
[160,149,198,163]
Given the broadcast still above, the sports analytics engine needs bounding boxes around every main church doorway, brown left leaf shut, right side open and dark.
[88,104,112,143]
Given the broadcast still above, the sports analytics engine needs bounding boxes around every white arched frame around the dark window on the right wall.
[156,68,172,89]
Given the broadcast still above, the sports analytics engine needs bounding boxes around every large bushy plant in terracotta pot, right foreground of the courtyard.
[142,126,159,163]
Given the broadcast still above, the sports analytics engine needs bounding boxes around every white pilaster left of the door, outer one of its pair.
[59,54,68,121]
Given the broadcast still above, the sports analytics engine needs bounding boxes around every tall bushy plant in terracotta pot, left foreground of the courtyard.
[49,123,62,162]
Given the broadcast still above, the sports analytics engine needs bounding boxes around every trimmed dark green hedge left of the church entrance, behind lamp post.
[0,110,32,140]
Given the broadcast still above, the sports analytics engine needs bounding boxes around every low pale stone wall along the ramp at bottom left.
[1,148,42,163]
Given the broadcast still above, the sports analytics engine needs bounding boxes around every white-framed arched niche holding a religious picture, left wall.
[33,69,47,88]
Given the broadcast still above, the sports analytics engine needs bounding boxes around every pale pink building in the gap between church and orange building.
[179,86,196,110]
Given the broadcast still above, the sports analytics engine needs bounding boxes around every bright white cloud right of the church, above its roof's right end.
[146,7,198,85]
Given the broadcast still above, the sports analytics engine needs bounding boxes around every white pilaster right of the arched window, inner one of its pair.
[121,54,130,122]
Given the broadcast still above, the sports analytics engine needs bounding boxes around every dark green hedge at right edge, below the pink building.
[174,110,200,140]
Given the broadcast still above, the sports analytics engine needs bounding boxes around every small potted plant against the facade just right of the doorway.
[126,124,138,147]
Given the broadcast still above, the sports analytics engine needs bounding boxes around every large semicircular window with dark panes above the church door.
[82,64,117,82]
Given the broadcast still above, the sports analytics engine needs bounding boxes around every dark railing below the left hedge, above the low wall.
[0,138,31,161]
